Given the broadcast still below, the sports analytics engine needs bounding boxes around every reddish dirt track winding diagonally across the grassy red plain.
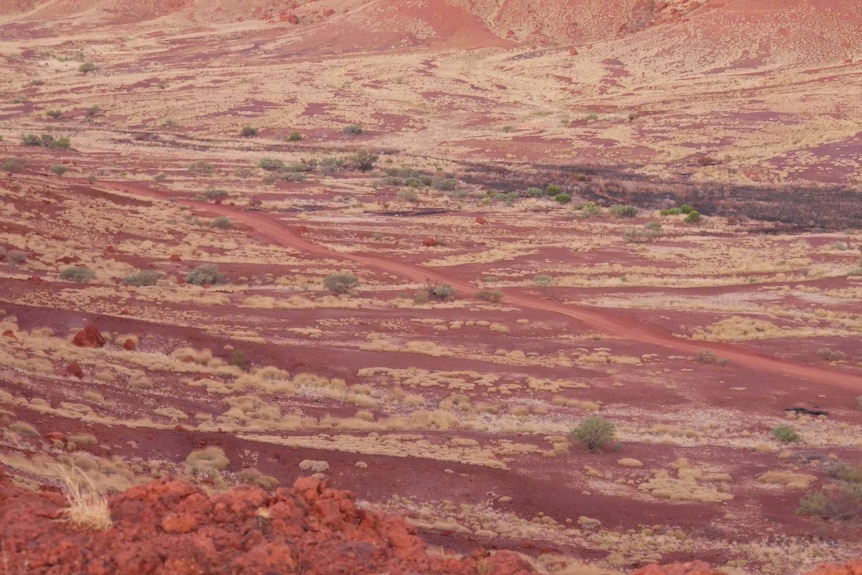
[110,183,862,391]
